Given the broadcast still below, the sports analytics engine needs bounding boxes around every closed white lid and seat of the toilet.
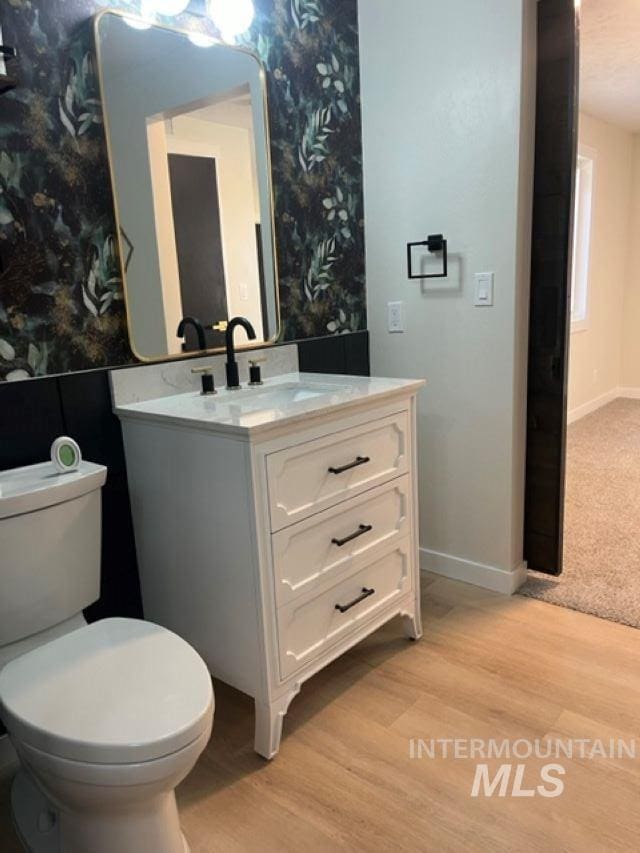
[0,619,213,764]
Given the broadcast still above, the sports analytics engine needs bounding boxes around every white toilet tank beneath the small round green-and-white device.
[0,462,107,646]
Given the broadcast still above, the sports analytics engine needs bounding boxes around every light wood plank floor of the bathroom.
[0,577,640,853]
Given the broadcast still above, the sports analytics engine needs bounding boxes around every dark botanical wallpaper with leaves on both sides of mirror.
[0,0,366,381]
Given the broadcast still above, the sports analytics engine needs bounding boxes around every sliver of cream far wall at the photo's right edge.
[620,135,640,394]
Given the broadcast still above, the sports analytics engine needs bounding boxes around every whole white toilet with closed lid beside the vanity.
[0,462,213,853]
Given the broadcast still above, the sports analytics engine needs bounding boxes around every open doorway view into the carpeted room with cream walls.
[524,0,640,627]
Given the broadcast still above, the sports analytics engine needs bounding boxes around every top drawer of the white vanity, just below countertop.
[267,411,409,531]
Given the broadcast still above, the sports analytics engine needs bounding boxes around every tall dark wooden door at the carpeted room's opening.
[524,0,578,574]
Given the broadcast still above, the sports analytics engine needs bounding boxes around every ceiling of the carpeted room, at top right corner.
[580,0,640,133]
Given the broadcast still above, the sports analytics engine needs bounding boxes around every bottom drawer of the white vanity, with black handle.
[278,538,412,679]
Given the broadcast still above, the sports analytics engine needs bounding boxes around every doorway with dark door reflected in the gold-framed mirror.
[147,86,268,351]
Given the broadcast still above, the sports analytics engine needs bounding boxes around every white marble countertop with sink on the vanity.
[114,373,425,437]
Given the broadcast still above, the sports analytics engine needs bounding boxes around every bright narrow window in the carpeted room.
[571,146,595,332]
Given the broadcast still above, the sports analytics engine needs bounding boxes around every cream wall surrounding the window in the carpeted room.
[568,113,640,420]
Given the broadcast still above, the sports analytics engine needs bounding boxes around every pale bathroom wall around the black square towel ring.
[359,0,535,591]
